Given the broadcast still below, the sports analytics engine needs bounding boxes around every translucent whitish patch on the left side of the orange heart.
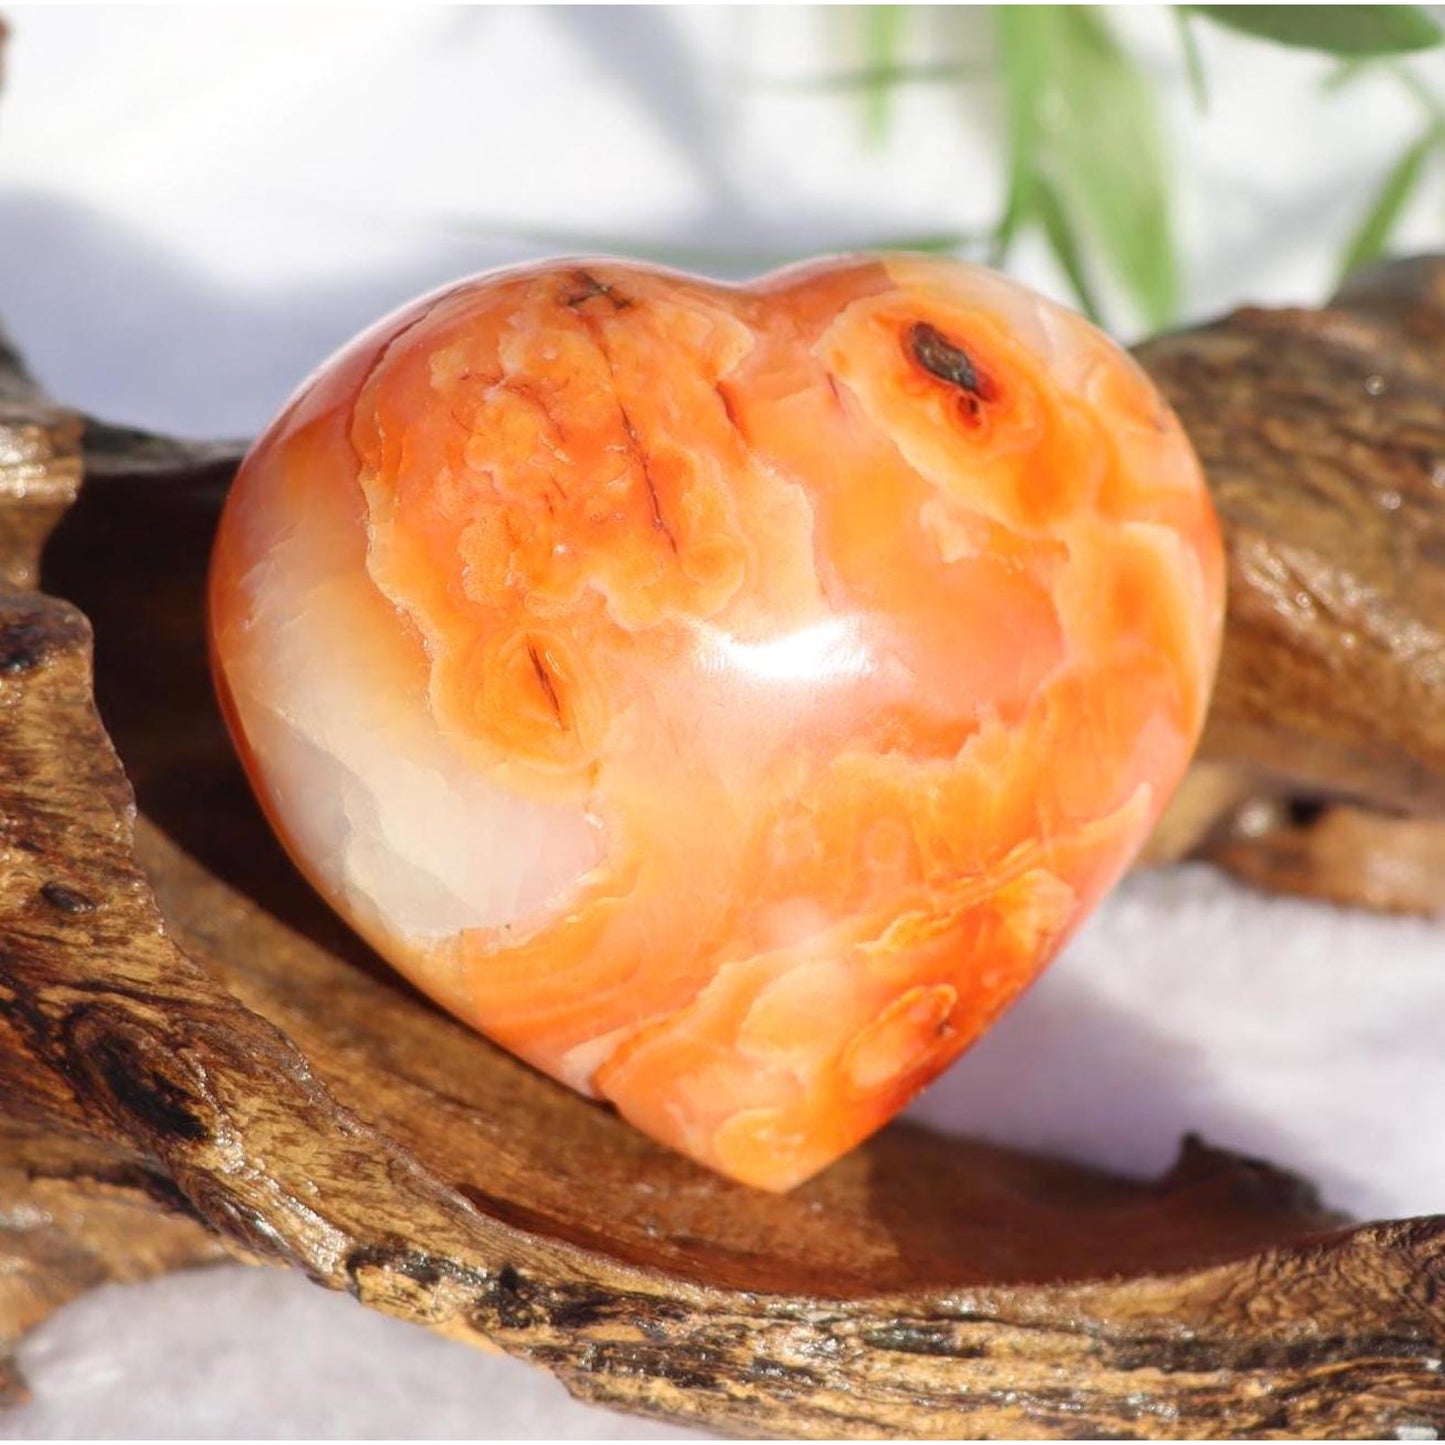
[233,539,600,941]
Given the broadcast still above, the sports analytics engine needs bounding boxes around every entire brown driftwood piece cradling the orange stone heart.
[0,263,1445,1436]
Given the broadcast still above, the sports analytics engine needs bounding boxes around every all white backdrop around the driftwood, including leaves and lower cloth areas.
[8,6,1445,1438]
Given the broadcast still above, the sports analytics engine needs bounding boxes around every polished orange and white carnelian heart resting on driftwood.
[211,256,1222,1189]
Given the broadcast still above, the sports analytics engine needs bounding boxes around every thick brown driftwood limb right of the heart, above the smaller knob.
[1139,259,1445,816]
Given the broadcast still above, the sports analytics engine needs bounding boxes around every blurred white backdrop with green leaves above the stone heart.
[8,6,1445,434]
